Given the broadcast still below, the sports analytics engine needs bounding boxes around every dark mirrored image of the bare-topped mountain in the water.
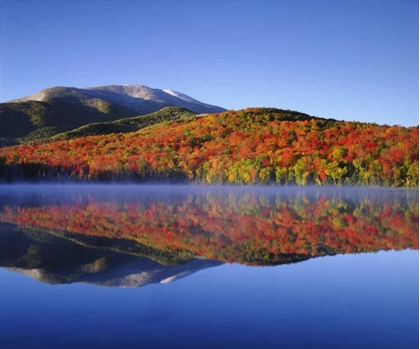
[0,224,222,287]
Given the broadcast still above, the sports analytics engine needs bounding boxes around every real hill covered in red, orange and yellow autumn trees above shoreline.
[0,108,419,187]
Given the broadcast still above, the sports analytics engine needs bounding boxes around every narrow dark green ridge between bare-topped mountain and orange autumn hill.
[51,107,197,141]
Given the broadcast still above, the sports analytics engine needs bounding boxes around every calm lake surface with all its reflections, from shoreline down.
[0,186,419,349]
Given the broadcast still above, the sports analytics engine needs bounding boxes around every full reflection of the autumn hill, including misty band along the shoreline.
[0,187,419,265]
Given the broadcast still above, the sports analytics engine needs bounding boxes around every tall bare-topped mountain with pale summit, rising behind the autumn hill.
[0,85,225,146]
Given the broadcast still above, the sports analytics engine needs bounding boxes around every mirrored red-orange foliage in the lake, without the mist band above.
[0,188,419,264]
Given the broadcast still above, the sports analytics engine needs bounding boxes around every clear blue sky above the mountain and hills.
[0,0,419,126]
